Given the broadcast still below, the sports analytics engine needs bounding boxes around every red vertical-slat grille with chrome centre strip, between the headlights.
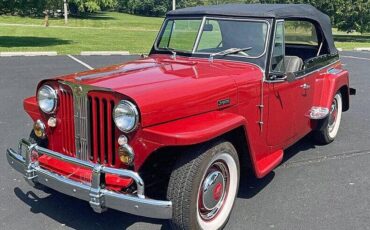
[58,82,120,167]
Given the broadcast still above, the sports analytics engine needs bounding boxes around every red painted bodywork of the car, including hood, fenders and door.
[24,55,348,180]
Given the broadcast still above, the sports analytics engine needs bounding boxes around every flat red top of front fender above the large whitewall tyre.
[143,111,246,146]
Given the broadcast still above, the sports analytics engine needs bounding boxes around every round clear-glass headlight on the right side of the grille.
[113,100,139,133]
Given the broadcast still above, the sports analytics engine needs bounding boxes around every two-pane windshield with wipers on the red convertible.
[156,18,268,58]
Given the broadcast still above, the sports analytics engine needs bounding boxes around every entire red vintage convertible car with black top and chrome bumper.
[7,4,355,229]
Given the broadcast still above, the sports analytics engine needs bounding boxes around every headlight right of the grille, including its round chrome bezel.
[113,100,139,133]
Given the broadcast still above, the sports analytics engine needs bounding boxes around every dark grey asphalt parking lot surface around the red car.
[0,52,370,230]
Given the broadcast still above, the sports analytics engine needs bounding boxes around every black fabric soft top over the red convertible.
[167,4,338,54]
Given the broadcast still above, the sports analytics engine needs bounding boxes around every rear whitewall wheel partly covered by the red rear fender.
[314,92,343,144]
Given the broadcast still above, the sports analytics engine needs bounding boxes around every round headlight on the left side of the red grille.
[37,85,58,114]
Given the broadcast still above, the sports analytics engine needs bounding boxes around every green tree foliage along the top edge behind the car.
[0,0,370,33]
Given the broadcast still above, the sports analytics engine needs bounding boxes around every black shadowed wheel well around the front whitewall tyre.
[139,127,252,199]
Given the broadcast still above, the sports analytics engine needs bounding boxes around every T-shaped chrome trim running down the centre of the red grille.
[59,81,111,161]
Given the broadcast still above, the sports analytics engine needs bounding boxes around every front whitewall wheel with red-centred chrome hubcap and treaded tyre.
[167,142,240,229]
